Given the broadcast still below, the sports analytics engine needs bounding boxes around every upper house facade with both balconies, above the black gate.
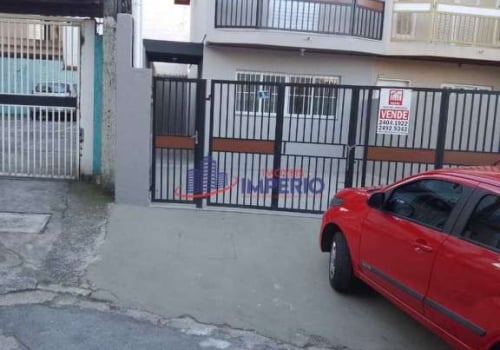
[186,0,500,90]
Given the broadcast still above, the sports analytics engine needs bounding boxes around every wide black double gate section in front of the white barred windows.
[208,81,359,212]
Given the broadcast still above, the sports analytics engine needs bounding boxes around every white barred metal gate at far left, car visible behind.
[0,17,80,179]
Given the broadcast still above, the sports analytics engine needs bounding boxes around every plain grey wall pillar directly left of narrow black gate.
[114,14,153,206]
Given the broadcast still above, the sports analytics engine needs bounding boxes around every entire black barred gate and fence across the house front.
[153,79,500,213]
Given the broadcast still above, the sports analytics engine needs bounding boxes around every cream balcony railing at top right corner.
[392,2,500,47]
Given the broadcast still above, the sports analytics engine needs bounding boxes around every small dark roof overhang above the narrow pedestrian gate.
[144,39,203,65]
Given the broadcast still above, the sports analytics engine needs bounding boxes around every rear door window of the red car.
[462,195,500,250]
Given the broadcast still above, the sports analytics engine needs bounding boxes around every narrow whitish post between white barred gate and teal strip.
[80,20,95,176]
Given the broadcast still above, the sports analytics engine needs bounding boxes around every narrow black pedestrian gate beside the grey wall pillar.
[151,77,208,206]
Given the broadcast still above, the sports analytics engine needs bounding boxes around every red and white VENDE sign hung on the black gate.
[377,88,411,135]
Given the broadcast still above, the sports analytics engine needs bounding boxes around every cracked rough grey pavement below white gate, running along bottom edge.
[0,179,340,350]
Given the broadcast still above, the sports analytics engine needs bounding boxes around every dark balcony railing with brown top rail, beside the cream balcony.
[215,0,384,40]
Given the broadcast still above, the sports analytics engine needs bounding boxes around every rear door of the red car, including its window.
[425,187,500,350]
